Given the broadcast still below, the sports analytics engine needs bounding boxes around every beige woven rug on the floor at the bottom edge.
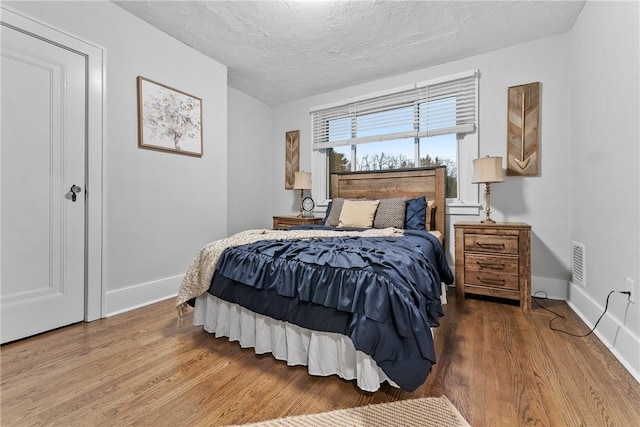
[230,396,470,427]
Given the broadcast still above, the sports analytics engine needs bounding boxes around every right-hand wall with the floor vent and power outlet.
[569,1,640,381]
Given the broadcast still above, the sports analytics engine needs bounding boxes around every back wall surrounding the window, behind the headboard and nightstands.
[271,34,570,298]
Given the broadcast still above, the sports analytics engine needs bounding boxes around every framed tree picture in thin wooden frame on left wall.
[137,76,203,157]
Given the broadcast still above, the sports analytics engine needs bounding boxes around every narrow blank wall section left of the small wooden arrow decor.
[227,87,274,234]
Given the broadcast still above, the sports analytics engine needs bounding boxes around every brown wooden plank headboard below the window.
[330,166,447,241]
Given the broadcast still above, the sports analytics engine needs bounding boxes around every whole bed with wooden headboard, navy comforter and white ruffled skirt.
[177,167,453,391]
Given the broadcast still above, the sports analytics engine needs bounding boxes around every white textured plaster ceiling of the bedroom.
[115,1,584,105]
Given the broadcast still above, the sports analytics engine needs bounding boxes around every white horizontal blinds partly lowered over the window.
[311,70,478,150]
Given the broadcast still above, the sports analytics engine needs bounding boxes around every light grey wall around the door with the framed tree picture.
[6,1,227,314]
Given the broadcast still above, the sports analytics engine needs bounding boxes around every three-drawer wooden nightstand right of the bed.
[454,222,531,310]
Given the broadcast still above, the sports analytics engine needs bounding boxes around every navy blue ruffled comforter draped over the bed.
[209,230,453,391]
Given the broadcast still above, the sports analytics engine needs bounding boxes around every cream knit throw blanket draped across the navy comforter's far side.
[176,228,404,323]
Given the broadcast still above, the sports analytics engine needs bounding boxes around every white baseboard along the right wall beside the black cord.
[567,283,640,383]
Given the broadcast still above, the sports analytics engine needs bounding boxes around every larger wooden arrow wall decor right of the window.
[507,82,540,176]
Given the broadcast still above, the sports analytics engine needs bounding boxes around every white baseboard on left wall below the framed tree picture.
[105,274,184,317]
